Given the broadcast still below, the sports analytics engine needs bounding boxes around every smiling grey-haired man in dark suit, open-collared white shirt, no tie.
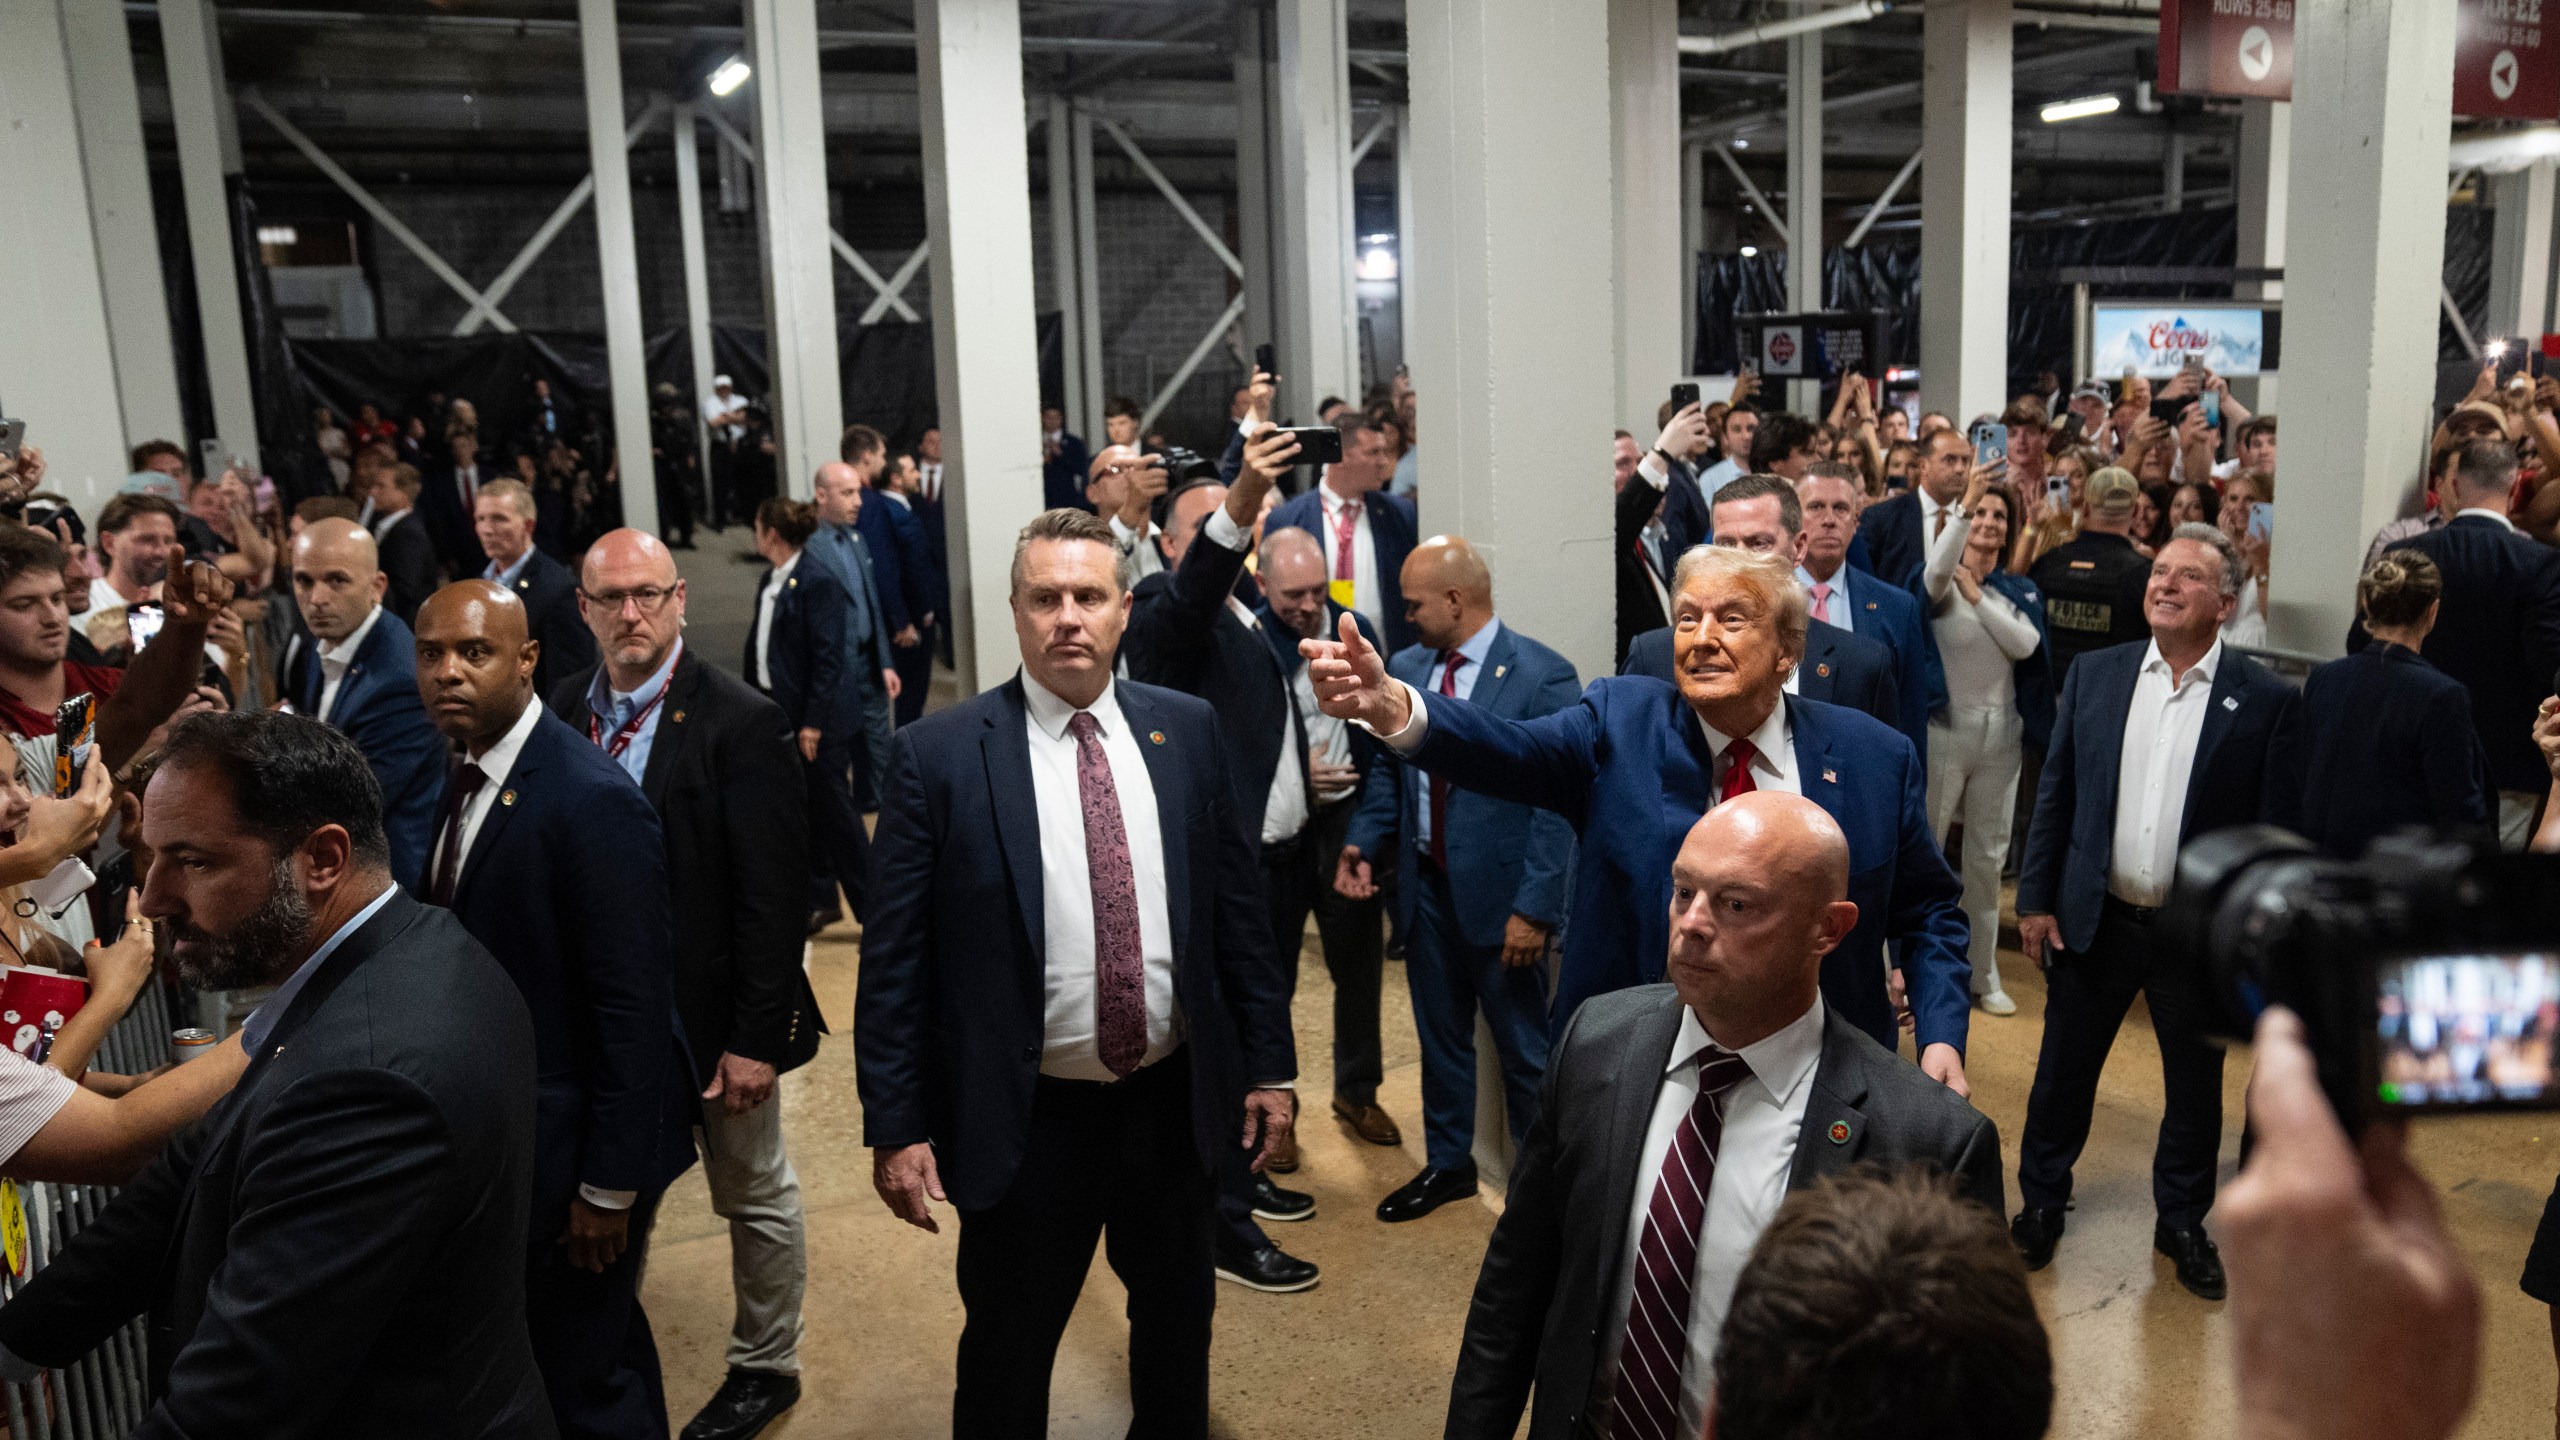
[2010,525,2301,1299]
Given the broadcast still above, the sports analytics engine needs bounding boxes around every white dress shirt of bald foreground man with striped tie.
[1600,994,1823,1435]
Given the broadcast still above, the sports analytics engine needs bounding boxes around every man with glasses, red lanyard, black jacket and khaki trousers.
[550,530,827,1440]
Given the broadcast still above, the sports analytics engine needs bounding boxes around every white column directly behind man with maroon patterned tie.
[916,0,1039,694]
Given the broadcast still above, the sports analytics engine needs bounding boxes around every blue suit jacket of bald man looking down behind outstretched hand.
[1344,625,1582,945]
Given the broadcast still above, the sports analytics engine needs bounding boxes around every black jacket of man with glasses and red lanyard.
[550,646,827,1086]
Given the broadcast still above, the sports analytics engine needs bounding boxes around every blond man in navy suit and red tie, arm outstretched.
[1308,546,1974,1094]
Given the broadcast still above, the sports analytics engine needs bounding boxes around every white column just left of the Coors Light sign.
[1920,0,2012,425]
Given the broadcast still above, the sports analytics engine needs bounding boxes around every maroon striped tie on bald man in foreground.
[1608,1045,1751,1440]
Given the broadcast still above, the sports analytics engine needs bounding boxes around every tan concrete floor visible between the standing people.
[629,536,2560,1440]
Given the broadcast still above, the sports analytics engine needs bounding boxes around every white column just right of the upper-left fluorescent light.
[747,0,844,500]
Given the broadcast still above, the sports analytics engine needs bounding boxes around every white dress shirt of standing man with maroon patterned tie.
[1021,671,1183,1081]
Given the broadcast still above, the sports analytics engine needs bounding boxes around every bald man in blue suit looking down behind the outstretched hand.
[1318,536,1582,1222]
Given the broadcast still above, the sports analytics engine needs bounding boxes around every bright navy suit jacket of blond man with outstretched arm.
[1413,676,1974,1051]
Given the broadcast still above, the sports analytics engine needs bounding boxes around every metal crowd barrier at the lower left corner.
[0,981,195,1440]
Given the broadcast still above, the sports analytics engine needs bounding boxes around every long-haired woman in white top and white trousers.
[1920,474,2053,1015]
